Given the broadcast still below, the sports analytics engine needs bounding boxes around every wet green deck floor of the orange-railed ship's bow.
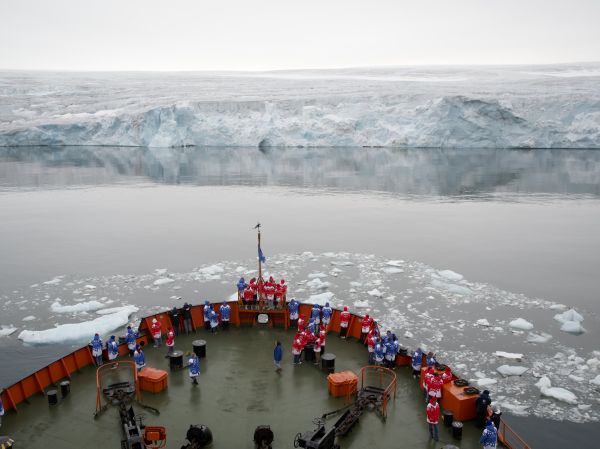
[1,327,479,449]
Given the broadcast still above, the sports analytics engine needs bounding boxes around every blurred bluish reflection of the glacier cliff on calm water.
[0,147,600,199]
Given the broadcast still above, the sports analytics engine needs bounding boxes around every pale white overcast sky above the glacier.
[0,0,600,70]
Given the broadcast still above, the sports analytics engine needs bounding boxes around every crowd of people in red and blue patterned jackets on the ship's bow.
[82,276,500,449]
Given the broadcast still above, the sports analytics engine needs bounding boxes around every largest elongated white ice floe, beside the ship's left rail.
[18,306,138,345]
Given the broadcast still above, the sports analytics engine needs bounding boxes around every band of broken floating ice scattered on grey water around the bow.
[0,252,600,422]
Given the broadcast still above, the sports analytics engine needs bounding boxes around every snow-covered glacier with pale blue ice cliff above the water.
[0,64,600,148]
